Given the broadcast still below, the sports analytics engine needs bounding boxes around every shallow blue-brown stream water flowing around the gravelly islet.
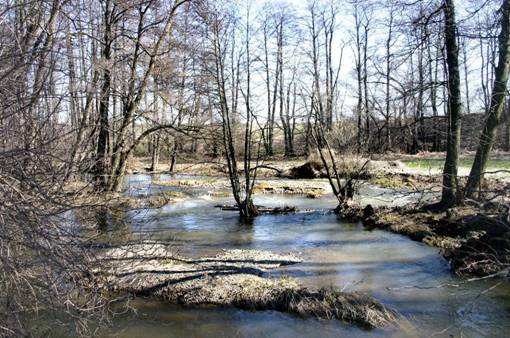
[100,175,510,338]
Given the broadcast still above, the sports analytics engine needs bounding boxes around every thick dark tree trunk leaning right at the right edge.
[465,0,510,197]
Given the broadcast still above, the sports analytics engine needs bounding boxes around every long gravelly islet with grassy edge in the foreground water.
[100,244,396,328]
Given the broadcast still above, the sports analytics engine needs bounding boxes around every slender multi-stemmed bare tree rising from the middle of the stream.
[203,4,259,219]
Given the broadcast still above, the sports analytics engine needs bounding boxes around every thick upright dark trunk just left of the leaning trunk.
[441,0,462,206]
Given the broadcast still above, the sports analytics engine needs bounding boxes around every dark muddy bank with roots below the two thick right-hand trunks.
[337,204,510,277]
